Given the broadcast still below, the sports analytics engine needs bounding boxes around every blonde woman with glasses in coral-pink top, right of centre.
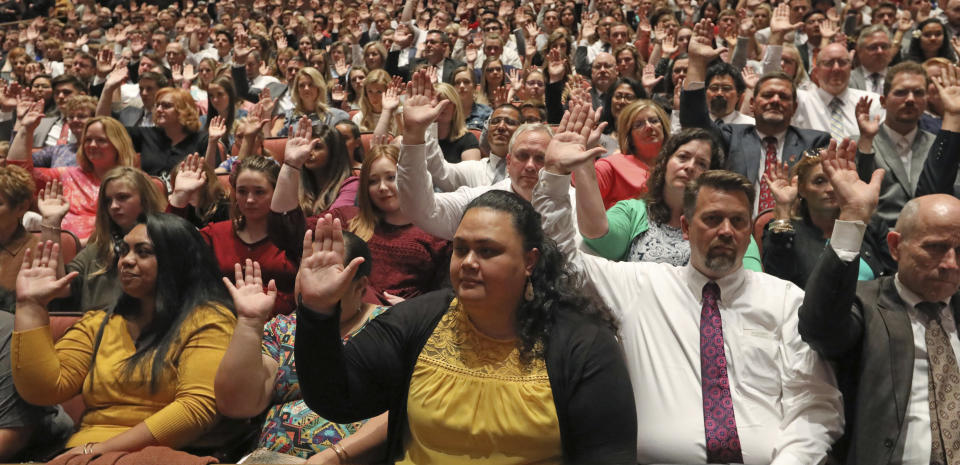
[594,99,670,209]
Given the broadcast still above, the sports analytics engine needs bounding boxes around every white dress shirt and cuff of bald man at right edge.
[830,220,960,465]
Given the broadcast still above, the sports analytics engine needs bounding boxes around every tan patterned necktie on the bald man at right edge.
[917,302,960,465]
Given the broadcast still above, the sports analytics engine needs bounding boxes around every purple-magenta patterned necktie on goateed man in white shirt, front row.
[700,281,743,463]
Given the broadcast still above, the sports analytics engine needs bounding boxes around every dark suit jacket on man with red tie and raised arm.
[680,89,830,183]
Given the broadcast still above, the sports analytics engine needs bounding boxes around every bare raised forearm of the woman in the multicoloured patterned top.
[213,317,277,418]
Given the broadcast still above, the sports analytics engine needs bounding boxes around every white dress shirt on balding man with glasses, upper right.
[792,88,886,139]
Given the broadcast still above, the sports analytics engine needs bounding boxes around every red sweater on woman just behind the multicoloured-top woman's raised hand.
[200,221,302,315]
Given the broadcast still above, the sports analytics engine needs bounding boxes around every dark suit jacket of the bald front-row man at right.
[799,247,960,465]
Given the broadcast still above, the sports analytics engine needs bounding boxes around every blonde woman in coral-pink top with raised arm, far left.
[7,102,136,244]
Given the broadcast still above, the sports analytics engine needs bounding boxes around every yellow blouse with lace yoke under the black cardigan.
[400,299,562,464]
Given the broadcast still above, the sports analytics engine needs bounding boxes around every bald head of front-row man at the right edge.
[887,194,960,302]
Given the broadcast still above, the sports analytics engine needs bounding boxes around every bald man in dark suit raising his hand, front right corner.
[799,143,960,465]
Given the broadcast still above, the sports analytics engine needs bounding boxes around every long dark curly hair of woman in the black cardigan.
[464,190,618,363]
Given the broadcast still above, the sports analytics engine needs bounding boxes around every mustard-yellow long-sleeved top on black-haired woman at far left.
[11,307,236,447]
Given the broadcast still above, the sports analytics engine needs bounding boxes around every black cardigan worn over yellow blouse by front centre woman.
[295,289,637,464]
